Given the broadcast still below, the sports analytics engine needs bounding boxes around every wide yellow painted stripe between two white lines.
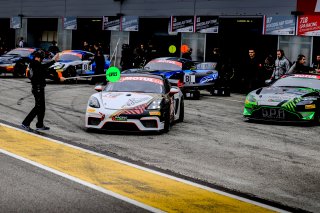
[0,124,271,212]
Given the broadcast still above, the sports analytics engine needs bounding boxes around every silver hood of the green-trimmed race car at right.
[250,87,316,106]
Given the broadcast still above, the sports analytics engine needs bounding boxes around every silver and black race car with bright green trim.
[243,74,320,123]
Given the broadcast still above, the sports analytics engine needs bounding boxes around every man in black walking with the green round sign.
[21,52,64,131]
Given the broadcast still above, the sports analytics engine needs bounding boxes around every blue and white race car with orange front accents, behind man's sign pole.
[49,50,110,82]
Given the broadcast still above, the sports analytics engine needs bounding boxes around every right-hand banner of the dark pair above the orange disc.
[196,16,219,33]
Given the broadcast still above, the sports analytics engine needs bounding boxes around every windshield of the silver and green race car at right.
[272,75,320,90]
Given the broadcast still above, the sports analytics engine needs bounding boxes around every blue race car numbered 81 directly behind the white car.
[123,57,218,99]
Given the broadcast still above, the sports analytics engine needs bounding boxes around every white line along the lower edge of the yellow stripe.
[0,149,163,213]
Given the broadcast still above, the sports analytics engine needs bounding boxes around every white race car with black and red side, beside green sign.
[85,74,184,132]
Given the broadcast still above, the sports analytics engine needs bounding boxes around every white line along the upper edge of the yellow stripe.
[0,122,288,212]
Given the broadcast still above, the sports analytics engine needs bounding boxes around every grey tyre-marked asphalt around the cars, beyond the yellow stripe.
[0,77,320,212]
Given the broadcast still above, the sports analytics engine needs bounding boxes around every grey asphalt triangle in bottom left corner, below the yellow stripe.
[0,153,149,213]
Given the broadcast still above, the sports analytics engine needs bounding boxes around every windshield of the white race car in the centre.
[104,77,164,94]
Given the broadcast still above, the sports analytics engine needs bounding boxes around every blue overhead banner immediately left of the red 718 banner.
[263,16,296,35]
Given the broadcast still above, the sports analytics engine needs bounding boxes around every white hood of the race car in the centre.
[101,92,162,110]
